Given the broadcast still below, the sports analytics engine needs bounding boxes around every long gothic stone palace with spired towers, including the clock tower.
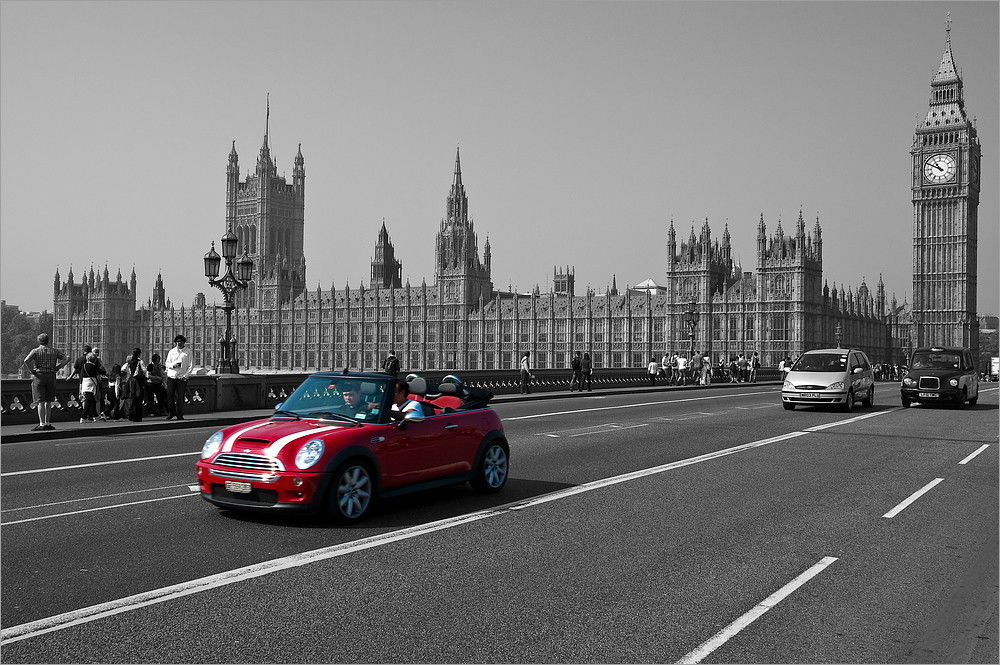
[53,23,980,372]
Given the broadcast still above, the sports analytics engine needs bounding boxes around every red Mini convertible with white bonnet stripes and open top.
[195,372,510,523]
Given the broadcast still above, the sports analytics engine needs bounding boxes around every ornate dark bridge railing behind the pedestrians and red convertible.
[0,367,779,425]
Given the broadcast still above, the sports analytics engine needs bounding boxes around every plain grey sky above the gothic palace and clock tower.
[0,0,1000,314]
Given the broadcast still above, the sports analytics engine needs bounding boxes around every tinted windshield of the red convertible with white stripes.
[281,376,389,422]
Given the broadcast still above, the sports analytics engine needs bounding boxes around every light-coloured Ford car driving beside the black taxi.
[781,349,875,412]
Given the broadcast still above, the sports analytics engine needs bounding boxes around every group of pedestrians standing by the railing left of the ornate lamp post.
[24,333,193,430]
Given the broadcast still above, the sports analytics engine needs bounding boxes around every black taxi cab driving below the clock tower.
[899,346,979,408]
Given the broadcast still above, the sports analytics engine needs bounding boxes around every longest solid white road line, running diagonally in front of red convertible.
[0,422,806,645]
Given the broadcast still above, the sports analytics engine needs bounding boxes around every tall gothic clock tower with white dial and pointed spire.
[910,14,980,357]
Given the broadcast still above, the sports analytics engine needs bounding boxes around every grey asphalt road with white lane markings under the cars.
[0,384,1000,663]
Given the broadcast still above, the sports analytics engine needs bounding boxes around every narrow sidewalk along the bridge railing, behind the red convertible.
[0,381,777,443]
